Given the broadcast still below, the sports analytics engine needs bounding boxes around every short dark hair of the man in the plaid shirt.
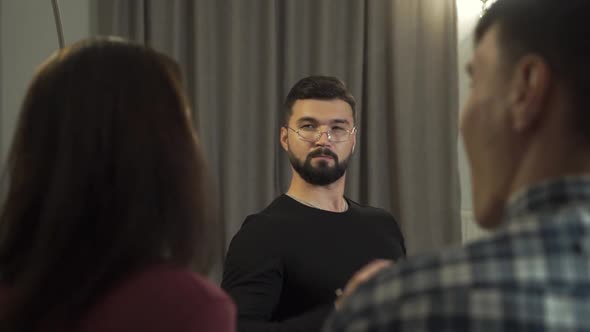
[475,0,590,138]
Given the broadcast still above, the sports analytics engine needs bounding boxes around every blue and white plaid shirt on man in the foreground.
[323,176,590,332]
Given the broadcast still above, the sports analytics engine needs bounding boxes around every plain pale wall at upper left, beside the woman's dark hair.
[0,0,91,164]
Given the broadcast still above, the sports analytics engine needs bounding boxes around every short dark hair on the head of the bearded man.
[284,76,356,123]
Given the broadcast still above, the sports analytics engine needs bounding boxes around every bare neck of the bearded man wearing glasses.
[287,172,348,212]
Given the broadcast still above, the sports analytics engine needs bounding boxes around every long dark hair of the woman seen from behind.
[0,39,216,331]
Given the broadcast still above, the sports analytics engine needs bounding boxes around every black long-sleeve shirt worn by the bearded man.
[222,195,405,332]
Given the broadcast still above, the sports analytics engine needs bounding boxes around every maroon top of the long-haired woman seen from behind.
[0,265,236,332]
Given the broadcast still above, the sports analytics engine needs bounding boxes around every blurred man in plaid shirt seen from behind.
[324,0,590,332]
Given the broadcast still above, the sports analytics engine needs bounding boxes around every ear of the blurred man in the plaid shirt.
[509,55,551,132]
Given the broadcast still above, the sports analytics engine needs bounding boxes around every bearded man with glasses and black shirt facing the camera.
[222,76,405,332]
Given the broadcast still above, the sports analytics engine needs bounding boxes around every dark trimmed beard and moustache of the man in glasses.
[288,148,348,186]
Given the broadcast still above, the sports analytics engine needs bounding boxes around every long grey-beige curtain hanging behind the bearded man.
[94,0,461,278]
